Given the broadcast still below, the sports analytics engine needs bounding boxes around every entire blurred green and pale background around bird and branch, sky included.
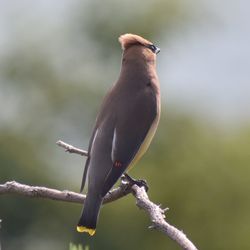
[0,0,250,250]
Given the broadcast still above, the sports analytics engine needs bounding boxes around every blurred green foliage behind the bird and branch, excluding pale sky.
[0,0,250,250]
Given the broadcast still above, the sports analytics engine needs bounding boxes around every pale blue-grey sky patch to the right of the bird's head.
[160,0,250,123]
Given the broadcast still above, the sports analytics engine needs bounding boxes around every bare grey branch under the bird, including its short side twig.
[0,141,197,250]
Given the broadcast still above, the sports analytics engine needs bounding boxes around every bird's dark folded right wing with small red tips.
[102,90,157,196]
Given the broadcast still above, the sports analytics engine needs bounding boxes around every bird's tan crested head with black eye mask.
[119,34,160,64]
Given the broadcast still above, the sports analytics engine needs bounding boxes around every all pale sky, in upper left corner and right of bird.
[0,0,250,127]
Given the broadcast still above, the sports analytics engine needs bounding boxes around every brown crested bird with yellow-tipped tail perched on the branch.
[77,33,160,236]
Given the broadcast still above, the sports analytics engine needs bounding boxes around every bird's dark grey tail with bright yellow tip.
[77,195,103,236]
